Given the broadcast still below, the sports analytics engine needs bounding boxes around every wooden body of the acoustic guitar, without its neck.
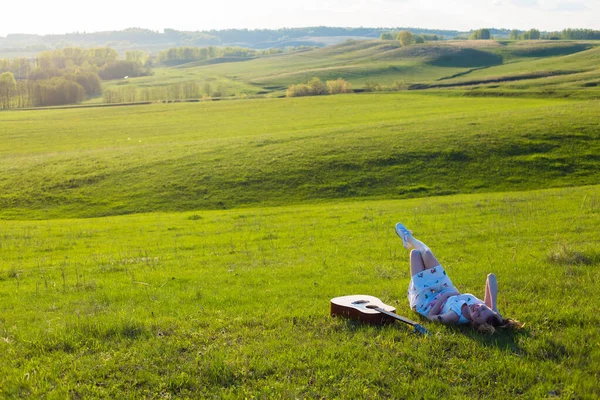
[330,294,396,325]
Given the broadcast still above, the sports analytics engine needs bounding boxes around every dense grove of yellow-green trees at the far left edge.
[0,47,151,109]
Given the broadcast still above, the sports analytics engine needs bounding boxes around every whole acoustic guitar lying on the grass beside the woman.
[330,294,429,335]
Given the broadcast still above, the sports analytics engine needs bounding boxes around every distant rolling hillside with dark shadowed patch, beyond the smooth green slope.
[106,40,600,97]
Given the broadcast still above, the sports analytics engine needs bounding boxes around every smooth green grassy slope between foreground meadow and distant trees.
[0,94,600,219]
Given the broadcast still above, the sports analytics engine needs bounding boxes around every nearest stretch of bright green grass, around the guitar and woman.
[0,186,600,399]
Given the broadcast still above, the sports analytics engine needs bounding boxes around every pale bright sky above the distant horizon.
[0,0,600,36]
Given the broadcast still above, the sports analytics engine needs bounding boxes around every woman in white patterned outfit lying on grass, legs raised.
[396,223,522,334]
